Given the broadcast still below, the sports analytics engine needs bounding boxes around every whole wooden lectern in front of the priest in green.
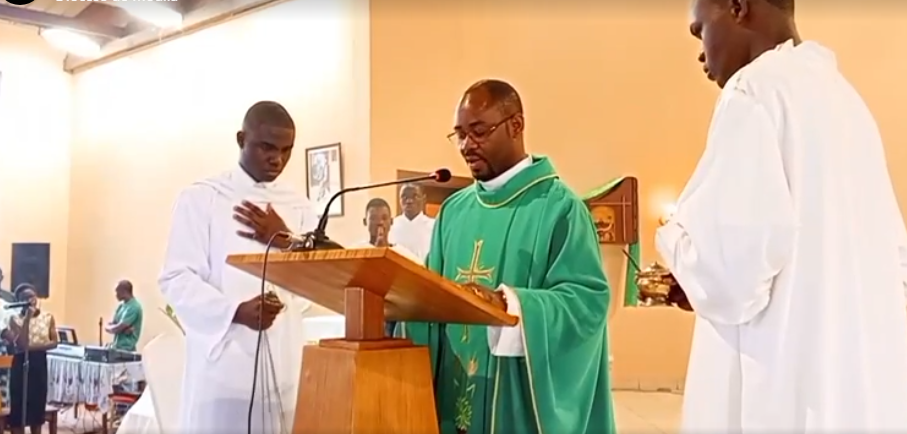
[227,248,517,434]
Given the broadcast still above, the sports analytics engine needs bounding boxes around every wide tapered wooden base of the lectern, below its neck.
[293,339,438,434]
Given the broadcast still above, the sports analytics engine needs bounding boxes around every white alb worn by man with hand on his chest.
[159,168,318,434]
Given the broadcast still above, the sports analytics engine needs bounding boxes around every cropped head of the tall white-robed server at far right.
[690,0,800,88]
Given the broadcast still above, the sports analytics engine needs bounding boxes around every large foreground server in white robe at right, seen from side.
[656,0,907,434]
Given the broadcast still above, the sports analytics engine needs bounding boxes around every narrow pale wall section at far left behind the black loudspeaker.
[0,22,72,323]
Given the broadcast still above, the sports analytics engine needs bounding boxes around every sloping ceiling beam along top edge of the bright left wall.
[63,0,288,73]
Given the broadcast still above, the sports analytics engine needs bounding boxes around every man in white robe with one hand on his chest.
[159,102,317,434]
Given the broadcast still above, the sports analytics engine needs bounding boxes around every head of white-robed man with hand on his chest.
[236,101,296,182]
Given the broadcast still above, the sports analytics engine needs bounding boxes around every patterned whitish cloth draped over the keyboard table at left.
[47,356,145,411]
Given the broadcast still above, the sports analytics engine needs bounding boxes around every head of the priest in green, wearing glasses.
[450,79,526,181]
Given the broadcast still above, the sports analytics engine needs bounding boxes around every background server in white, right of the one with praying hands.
[388,184,435,263]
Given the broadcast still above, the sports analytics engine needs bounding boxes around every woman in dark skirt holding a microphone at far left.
[0,283,57,434]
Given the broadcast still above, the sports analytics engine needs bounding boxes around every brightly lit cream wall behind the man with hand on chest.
[67,0,369,342]
